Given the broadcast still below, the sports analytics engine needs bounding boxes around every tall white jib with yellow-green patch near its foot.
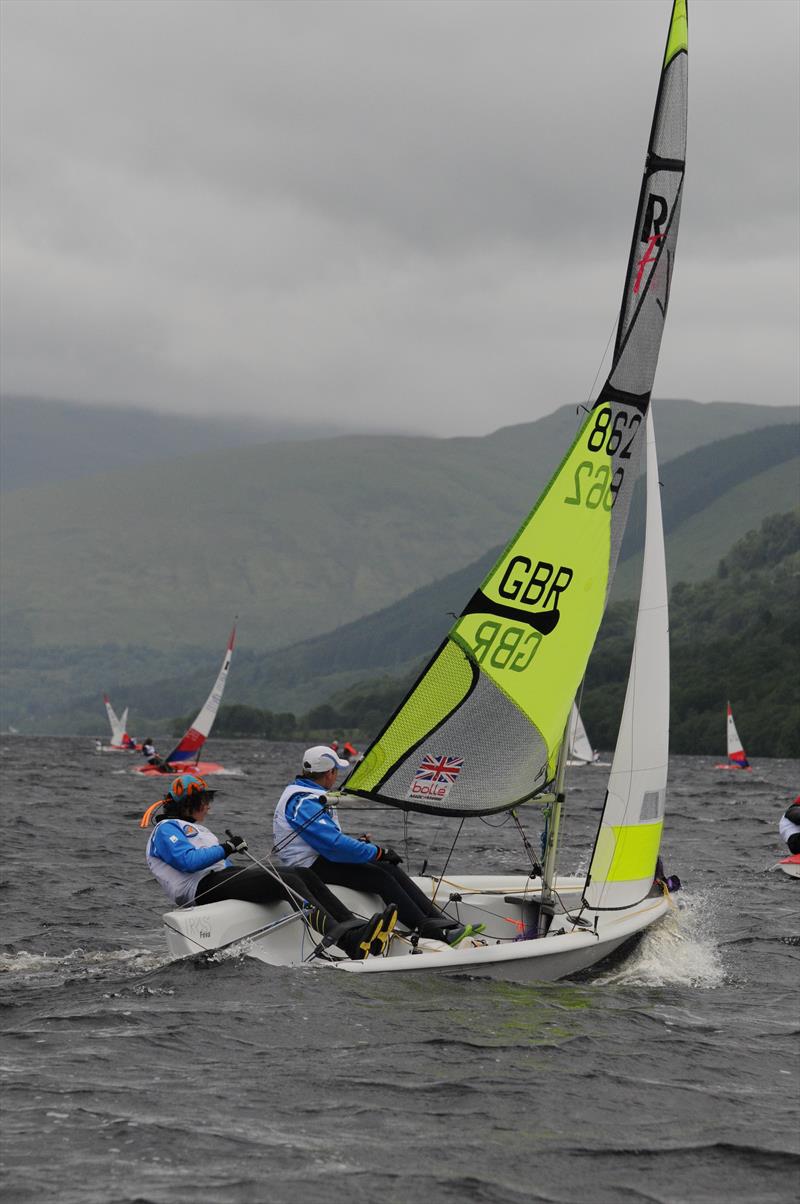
[584,411,670,909]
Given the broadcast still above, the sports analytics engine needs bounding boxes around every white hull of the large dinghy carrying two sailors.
[164,875,670,982]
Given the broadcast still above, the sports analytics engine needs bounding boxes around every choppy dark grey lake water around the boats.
[0,737,800,1204]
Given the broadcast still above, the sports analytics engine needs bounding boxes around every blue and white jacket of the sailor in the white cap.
[272,778,378,867]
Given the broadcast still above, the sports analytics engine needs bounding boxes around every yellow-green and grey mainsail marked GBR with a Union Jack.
[345,0,687,815]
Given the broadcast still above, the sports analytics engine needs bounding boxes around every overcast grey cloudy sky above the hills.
[0,0,800,435]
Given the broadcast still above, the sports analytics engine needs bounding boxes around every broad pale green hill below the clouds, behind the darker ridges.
[1,401,794,650]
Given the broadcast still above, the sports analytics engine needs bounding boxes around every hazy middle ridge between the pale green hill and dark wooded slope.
[9,418,800,732]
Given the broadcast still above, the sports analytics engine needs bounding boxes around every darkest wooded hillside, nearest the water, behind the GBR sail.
[207,513,800,757]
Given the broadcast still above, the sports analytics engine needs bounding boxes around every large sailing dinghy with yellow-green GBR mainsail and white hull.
[164,0,688,982]
